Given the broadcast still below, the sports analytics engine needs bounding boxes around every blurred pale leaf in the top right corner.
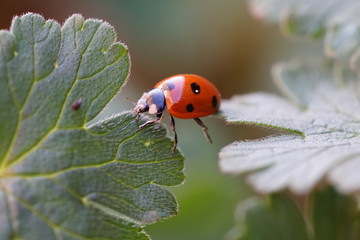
[249,0,360,71]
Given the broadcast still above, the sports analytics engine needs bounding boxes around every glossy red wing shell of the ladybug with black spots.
[155,74,221,119]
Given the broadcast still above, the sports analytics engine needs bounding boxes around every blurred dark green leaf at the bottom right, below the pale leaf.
[225,187,360,240]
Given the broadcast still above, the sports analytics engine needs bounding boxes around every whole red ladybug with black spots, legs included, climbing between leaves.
[134,74,221,152]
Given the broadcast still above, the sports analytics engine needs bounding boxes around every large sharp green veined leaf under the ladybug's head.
[0,14,184,240]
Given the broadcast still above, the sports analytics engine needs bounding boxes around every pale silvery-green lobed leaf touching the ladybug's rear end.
[220,61,360,194]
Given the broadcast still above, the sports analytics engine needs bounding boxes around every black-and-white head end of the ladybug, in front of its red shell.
[134,88,166,118]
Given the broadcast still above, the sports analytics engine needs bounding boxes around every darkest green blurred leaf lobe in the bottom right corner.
[312,188,360,240]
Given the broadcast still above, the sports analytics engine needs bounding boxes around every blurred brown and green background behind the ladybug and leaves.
[0,0,320,240]
